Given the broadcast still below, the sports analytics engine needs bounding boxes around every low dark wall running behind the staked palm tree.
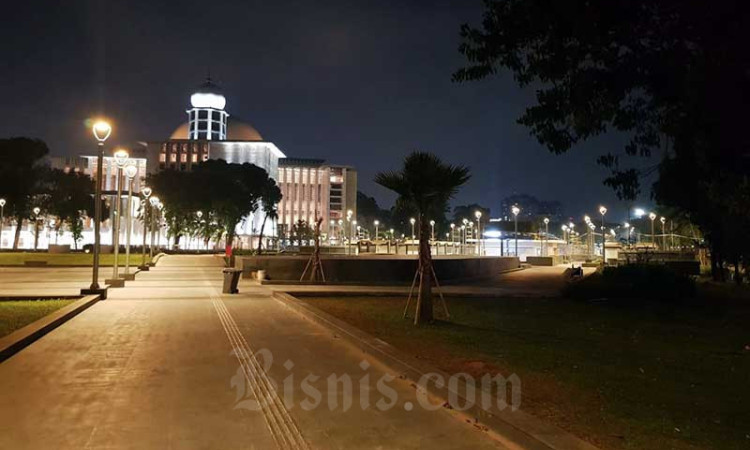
[241,255,520,284]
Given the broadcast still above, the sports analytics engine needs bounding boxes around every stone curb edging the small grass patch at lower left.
[0,295,99,363]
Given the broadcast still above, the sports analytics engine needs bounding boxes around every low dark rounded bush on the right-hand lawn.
[563,264,695,302]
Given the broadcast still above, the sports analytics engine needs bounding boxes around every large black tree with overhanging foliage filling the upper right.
[454,0,750,280]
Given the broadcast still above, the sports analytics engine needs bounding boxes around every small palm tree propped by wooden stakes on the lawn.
[375,152,471,325]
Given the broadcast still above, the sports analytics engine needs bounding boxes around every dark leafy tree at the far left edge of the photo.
[0,137,49,250]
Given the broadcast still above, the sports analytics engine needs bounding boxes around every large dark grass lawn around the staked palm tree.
[303,297,750,449]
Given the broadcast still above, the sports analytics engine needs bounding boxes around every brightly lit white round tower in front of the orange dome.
[187,77,229,141]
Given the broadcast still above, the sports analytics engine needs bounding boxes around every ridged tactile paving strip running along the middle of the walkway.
[211,298,309,450]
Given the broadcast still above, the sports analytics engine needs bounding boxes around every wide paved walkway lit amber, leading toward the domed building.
[0,256,508,449]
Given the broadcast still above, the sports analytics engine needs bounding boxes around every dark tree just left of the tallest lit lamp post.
[45,169,95,249]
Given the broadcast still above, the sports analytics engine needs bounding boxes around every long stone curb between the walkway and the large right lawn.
[272,292,598,450]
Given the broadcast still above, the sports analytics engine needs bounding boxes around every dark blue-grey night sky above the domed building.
[0,0,648,218]
